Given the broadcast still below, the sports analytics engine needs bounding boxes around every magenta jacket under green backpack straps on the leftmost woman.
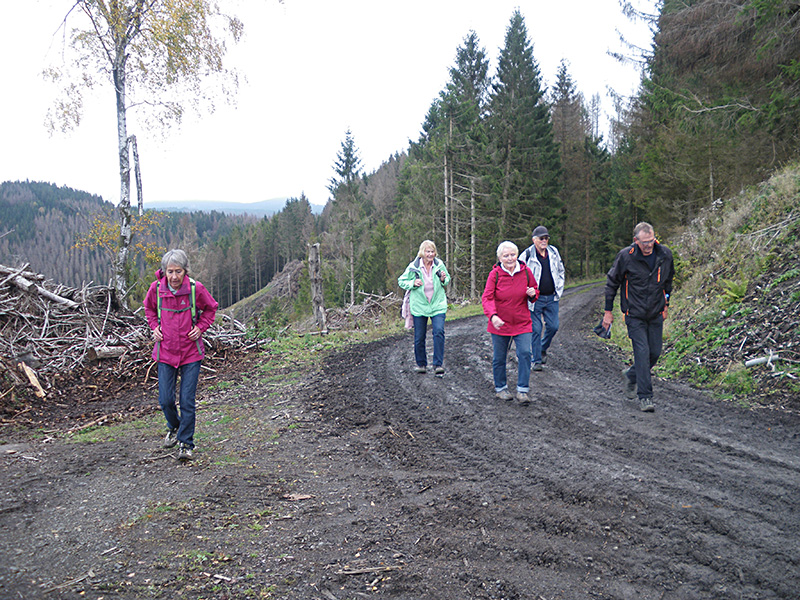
[144,269,219,368]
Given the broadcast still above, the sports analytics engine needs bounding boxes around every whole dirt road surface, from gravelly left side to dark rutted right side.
[0,288,800,600]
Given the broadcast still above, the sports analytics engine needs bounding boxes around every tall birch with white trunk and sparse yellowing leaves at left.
[45,0,264,304]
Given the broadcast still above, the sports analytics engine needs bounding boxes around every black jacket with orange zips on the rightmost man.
[605,242,675,321]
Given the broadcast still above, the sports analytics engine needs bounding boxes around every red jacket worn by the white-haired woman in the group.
[481,260,539,335]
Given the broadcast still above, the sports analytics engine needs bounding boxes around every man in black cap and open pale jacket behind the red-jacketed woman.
[520,225,564,371]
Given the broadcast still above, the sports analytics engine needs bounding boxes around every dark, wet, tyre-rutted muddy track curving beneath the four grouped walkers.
[312,289,800,598]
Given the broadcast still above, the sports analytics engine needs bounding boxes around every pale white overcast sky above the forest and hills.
[0,0,653,209]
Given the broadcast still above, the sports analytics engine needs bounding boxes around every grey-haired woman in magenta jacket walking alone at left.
[144,250,219,460]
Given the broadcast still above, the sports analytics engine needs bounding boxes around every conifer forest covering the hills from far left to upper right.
[0,0,800,318]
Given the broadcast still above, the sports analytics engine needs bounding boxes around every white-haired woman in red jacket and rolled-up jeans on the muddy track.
[481,241,539,406]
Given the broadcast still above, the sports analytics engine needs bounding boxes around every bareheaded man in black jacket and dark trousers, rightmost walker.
[603,223,675,412]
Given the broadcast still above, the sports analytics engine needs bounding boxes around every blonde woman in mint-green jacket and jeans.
[397,240,450,375]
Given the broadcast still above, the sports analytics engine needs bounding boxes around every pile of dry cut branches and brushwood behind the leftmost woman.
[0,265,259,422]
